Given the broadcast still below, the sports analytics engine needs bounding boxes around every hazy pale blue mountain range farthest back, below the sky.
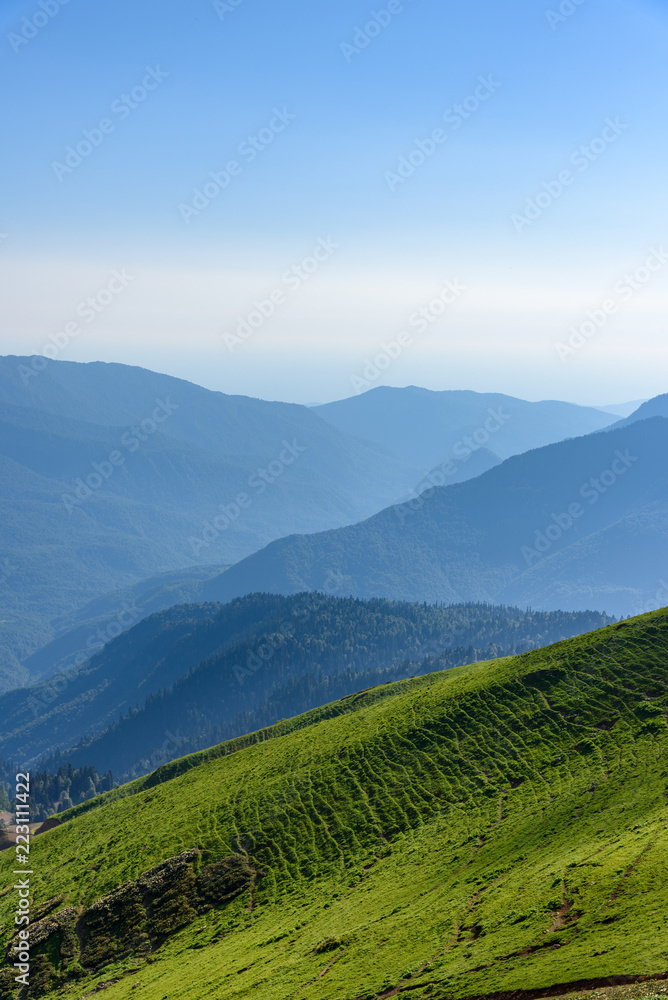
[0,357,615,690]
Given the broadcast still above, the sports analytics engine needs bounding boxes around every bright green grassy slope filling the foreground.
[0,611,668,1000]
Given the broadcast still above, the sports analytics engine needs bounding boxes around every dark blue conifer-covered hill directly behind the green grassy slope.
[0,594,609,779]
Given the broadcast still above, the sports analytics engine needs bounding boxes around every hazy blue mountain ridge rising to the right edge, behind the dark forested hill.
[203,417,668,615]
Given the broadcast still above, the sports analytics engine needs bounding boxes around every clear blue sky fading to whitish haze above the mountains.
[0,0,668,405]
